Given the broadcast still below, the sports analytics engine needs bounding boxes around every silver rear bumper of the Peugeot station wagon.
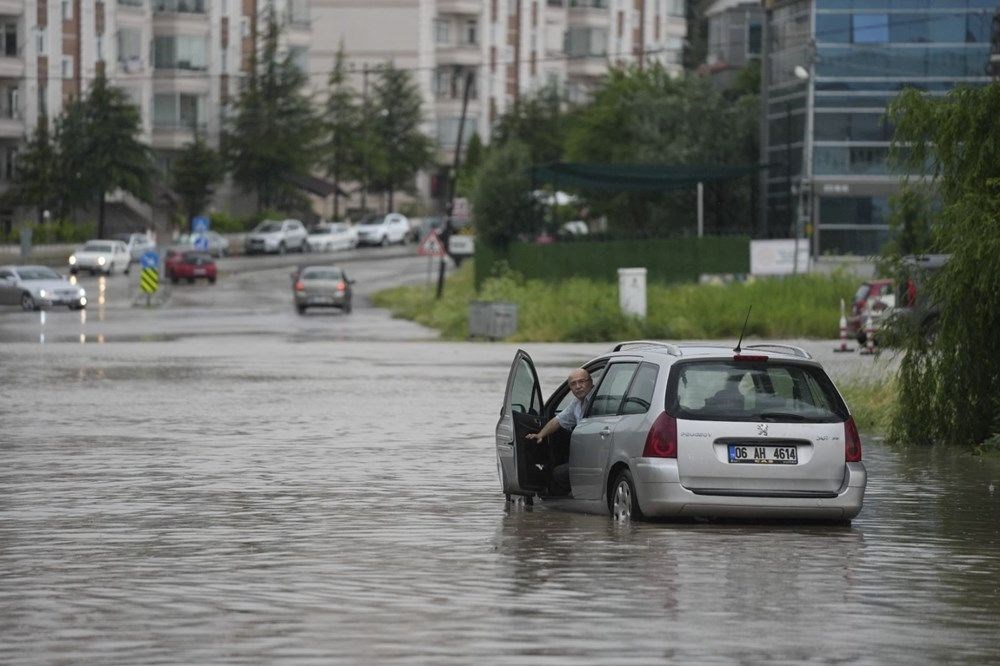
[631,458,868,520]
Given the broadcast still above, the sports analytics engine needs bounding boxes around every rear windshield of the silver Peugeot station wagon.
[668,361,847,423]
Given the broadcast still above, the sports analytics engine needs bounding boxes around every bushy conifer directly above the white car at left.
[56,70,153,238]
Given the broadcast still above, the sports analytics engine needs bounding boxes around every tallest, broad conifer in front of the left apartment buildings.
[223,13,323,212]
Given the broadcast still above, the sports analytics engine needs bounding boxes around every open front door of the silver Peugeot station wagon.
[496,349,547,496]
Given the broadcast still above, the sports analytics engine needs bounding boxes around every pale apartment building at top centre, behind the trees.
[310,0,687,157]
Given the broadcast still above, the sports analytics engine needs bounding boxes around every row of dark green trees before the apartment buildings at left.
[4,16,434,237]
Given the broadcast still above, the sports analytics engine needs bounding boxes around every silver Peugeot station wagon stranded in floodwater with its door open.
[496,341,867,522]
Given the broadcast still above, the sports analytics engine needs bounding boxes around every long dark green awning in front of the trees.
[531,162,764,192]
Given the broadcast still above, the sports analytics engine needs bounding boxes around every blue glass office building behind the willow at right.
[761,0,1000,255]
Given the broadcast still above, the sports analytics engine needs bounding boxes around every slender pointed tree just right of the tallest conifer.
[324,43,364,218]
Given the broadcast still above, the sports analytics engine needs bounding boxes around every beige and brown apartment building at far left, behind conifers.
[0,0,311,226]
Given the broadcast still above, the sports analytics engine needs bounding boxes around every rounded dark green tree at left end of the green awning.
[472,141,535,247]
